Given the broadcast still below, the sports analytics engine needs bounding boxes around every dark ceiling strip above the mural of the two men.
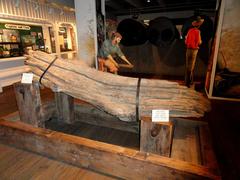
[105,0,219,16]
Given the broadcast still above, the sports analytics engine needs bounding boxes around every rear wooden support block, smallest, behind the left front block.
[55,92,74,124]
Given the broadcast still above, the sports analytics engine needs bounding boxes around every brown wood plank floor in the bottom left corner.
[0,144,115,180]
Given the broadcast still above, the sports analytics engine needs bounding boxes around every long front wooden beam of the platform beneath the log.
[0,120,220,179]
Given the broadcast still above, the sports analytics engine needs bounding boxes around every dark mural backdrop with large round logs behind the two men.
[102,11,215,79]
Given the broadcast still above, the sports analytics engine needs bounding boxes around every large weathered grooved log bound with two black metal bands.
[26,51,210,121]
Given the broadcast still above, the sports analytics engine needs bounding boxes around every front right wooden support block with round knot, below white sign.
[140,117,173,157]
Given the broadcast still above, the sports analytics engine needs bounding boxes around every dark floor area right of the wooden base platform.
[207,100,240,180]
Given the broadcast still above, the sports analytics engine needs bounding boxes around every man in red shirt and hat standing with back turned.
[185,16,204,87]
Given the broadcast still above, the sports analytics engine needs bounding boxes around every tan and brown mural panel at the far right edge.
[213,0,240,98]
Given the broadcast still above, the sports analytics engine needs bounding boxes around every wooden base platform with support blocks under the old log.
[0,84,221,179]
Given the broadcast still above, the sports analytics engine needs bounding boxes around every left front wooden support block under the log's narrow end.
[14,82,44,127]
